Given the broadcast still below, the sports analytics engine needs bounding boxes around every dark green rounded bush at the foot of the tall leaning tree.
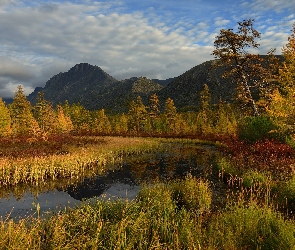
[238,116,278,143]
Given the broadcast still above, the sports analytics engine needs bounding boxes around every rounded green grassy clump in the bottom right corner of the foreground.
[208,204,295,250]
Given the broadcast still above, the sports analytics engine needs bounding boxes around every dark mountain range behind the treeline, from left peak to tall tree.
[28,56,282,113]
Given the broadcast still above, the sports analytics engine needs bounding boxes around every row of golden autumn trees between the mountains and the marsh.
[0,85,237,138]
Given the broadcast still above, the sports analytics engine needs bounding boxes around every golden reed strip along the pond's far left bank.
[0,137,160,186]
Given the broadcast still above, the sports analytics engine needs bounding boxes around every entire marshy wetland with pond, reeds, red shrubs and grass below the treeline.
[0,136,295,249]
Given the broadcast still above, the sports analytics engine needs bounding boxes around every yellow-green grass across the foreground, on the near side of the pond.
[0,176,295,249]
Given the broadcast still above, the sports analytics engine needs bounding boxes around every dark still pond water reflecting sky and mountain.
[0,145,219,219]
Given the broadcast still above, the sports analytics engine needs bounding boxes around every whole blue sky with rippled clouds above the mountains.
[0,0,295,98]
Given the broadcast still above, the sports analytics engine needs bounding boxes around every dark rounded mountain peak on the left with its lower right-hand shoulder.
[28,63,163,112]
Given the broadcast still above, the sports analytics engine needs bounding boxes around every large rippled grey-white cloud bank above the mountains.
[0,2,217,97]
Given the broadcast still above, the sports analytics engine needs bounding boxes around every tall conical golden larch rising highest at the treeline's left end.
[9,85,40,135]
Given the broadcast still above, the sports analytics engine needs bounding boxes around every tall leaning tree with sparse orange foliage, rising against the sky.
[212,19,278,116]
